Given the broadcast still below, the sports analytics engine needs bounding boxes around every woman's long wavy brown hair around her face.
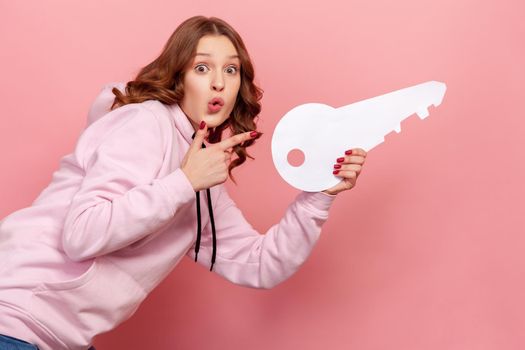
[111,16,263,183]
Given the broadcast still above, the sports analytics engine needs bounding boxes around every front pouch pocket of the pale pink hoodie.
[30,257,146,349]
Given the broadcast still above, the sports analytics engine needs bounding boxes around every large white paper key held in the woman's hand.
[272,81,447,192]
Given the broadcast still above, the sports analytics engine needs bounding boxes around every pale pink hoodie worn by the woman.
[0,84,336,350]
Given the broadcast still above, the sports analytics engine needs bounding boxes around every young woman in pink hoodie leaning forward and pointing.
[0,16,366,350]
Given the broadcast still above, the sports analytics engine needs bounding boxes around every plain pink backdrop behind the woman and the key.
[0,0,525,350]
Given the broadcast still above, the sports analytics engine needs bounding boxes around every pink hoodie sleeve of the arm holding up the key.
[187,185,336,289]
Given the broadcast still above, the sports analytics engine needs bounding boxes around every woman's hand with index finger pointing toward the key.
[181,121,258,191]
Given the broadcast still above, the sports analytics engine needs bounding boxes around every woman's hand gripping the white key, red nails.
[323,148,366,195]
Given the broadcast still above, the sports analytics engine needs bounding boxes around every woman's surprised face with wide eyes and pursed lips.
[179,35,241,130]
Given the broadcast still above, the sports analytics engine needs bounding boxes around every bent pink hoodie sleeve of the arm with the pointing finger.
[62,105,195,261]
